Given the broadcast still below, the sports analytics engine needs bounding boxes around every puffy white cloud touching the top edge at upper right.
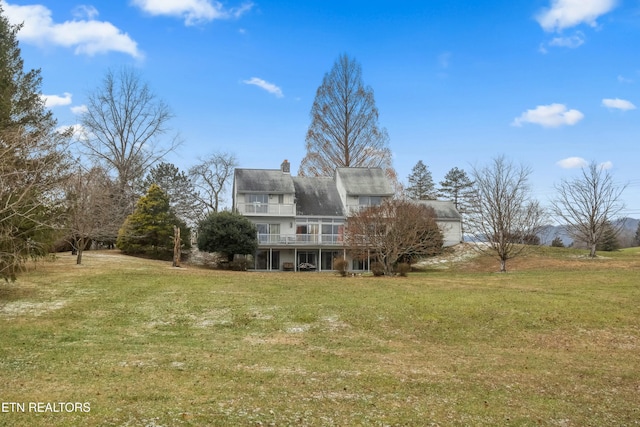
[536,0,617,32]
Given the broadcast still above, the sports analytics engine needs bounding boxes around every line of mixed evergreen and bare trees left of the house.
[0,6,237,280]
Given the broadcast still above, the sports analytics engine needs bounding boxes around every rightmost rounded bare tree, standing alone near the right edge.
[551,162,626,257]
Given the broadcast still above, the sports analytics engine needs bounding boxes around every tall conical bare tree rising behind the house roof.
[298,55,395,177]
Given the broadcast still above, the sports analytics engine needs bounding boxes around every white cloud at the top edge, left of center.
[132,0,253,25]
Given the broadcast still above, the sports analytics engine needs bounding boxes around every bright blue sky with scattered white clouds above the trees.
[0,0,640,217]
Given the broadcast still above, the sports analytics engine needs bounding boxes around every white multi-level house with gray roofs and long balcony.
[233,160,462,271]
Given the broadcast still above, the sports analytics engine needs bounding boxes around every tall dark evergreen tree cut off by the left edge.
[0,4,71,280]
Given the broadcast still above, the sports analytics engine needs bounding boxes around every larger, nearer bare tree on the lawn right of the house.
[468,156,545,272]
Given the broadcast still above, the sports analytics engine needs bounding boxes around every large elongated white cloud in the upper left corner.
[2,2,142,58]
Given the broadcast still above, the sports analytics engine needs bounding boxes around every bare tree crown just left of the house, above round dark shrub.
[189,153,238,215]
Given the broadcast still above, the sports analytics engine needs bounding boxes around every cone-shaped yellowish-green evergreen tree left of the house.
[116,184,189,256]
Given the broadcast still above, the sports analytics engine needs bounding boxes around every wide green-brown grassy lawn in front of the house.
[0,248,640,426]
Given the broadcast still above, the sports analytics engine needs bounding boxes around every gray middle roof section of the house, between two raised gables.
[293,177,343,216]
